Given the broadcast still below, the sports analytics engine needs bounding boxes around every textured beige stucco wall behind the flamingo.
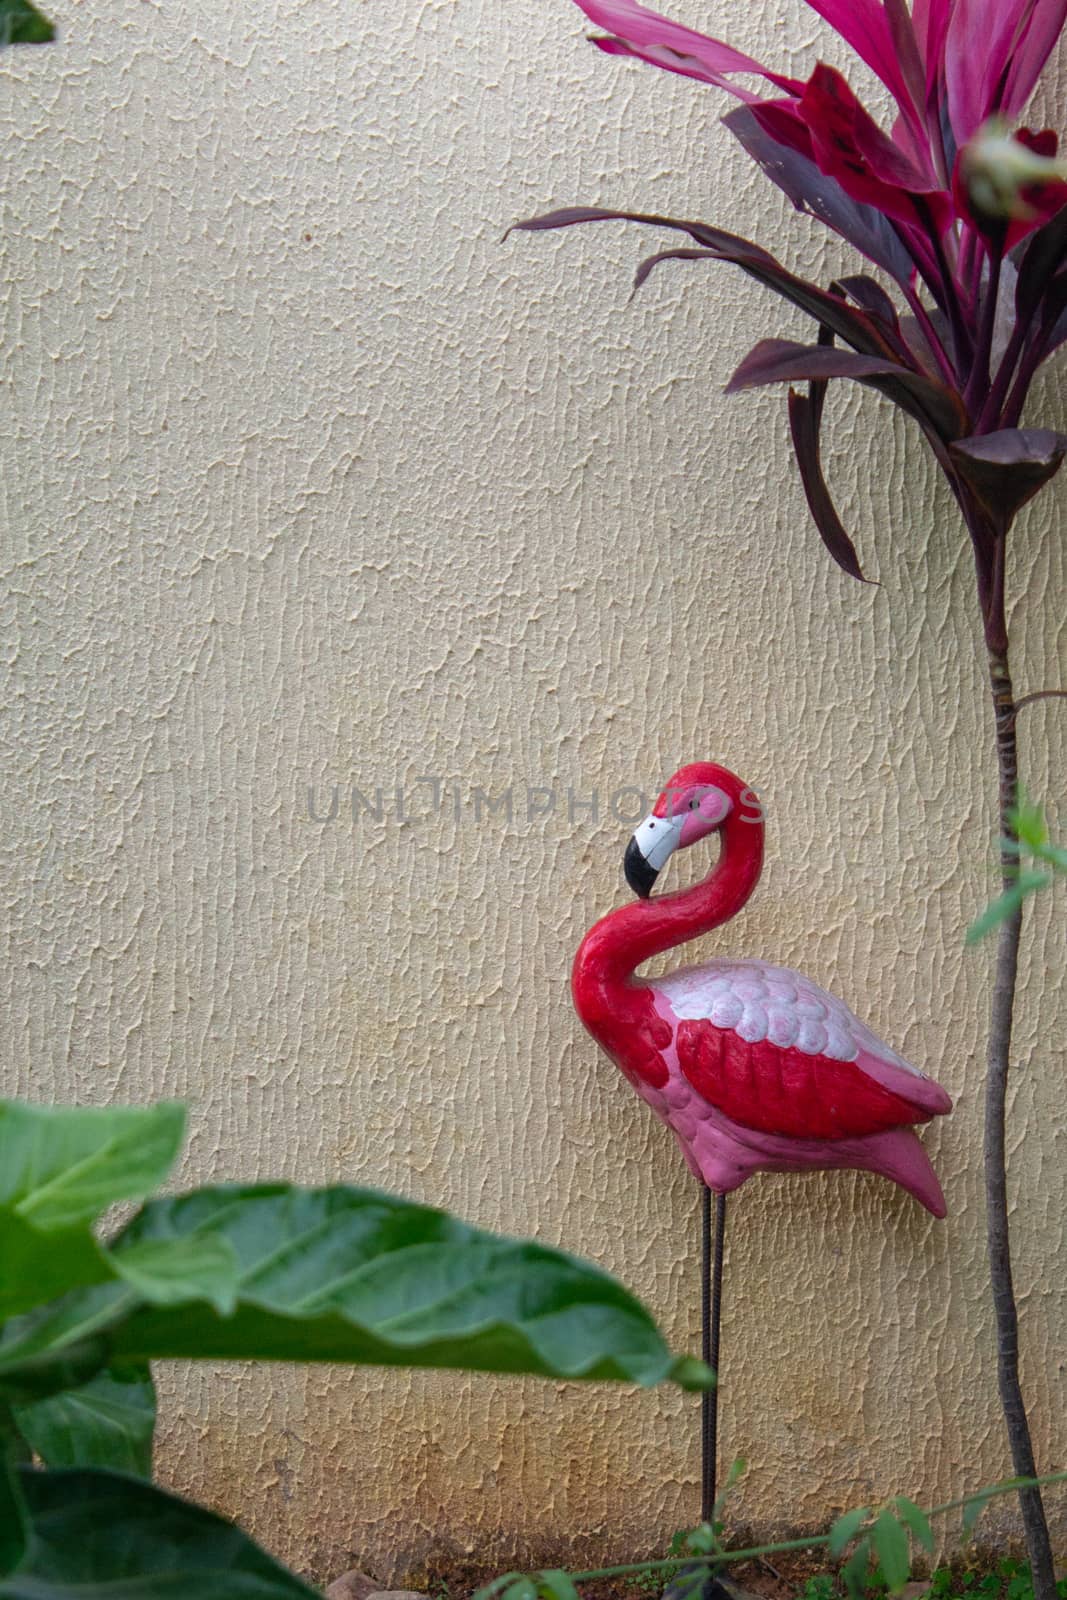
[0,0,1067,1574]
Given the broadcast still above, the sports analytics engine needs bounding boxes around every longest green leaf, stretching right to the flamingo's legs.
[0,1184,710,1395]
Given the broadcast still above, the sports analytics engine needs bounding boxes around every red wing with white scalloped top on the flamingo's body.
[651,962,952,1139]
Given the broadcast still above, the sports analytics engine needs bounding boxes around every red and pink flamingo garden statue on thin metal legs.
[571,762,952,1518]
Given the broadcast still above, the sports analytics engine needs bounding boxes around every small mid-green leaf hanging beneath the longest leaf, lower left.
[13,1366,155,1478]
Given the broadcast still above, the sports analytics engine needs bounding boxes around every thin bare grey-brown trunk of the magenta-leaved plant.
[984,646,1056,1600]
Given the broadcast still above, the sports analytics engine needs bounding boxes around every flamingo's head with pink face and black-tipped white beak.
[622,762,761,899]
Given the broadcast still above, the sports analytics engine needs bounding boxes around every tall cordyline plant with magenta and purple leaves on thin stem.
[520,0,1067,1600]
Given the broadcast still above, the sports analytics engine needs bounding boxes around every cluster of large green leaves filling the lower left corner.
[0,1101,712,1600]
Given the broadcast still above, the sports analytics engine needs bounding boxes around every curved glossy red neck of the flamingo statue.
[573,813,763,1043]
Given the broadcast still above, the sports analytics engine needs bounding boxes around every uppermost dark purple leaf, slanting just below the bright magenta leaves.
[723,106,913,285]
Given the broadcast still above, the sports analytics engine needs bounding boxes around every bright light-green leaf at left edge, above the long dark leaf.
[0,1101,186,1318]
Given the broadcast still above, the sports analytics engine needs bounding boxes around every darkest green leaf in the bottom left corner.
[0,1470,315,1600]
